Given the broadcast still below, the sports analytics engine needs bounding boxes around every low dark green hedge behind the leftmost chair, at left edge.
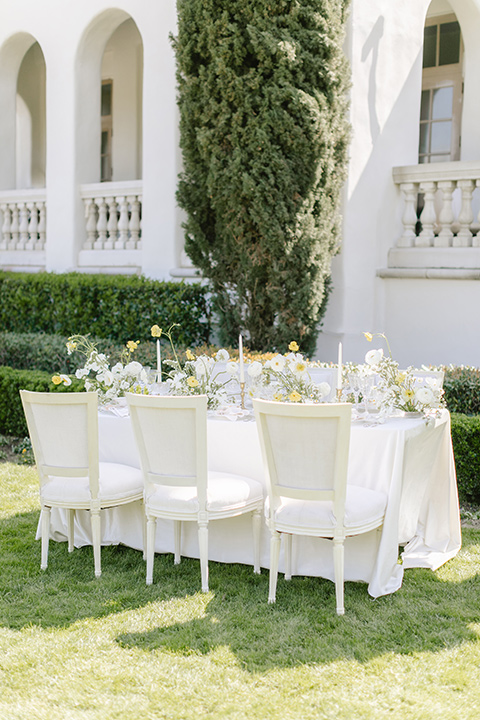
[0,367,84,437]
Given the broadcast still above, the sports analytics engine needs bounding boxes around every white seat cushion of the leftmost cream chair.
[40,462,143,507]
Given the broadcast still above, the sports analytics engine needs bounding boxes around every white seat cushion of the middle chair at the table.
[145,471,263,515]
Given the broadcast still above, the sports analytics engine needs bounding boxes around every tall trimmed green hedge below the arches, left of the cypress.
[0,272,211,346]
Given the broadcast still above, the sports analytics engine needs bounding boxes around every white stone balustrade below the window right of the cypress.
[393,162,480,248]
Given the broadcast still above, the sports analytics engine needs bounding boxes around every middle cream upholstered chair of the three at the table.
[127,394,264,592]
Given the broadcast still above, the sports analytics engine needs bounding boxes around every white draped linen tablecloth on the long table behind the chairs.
[42,410,461,597]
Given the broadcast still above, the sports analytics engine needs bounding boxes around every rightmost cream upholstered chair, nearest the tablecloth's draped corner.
[253,399,387,615]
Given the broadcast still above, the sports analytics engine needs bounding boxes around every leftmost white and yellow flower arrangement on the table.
[62,335,148,404]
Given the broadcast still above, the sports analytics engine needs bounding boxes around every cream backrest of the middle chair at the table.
[127,393,207,510]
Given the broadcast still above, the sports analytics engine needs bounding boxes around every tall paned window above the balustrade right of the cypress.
[418,15,463,163]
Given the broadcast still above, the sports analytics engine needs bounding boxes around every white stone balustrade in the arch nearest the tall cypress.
[80,180,142,251]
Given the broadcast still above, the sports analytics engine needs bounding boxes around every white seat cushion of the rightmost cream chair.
[265,485,387,530]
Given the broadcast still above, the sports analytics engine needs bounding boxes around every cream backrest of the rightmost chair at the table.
[253,399,351,525]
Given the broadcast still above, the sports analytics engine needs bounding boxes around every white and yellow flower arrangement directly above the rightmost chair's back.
[247,341,331,403]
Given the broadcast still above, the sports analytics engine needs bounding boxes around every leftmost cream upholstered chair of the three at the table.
[20,390,143,577]
